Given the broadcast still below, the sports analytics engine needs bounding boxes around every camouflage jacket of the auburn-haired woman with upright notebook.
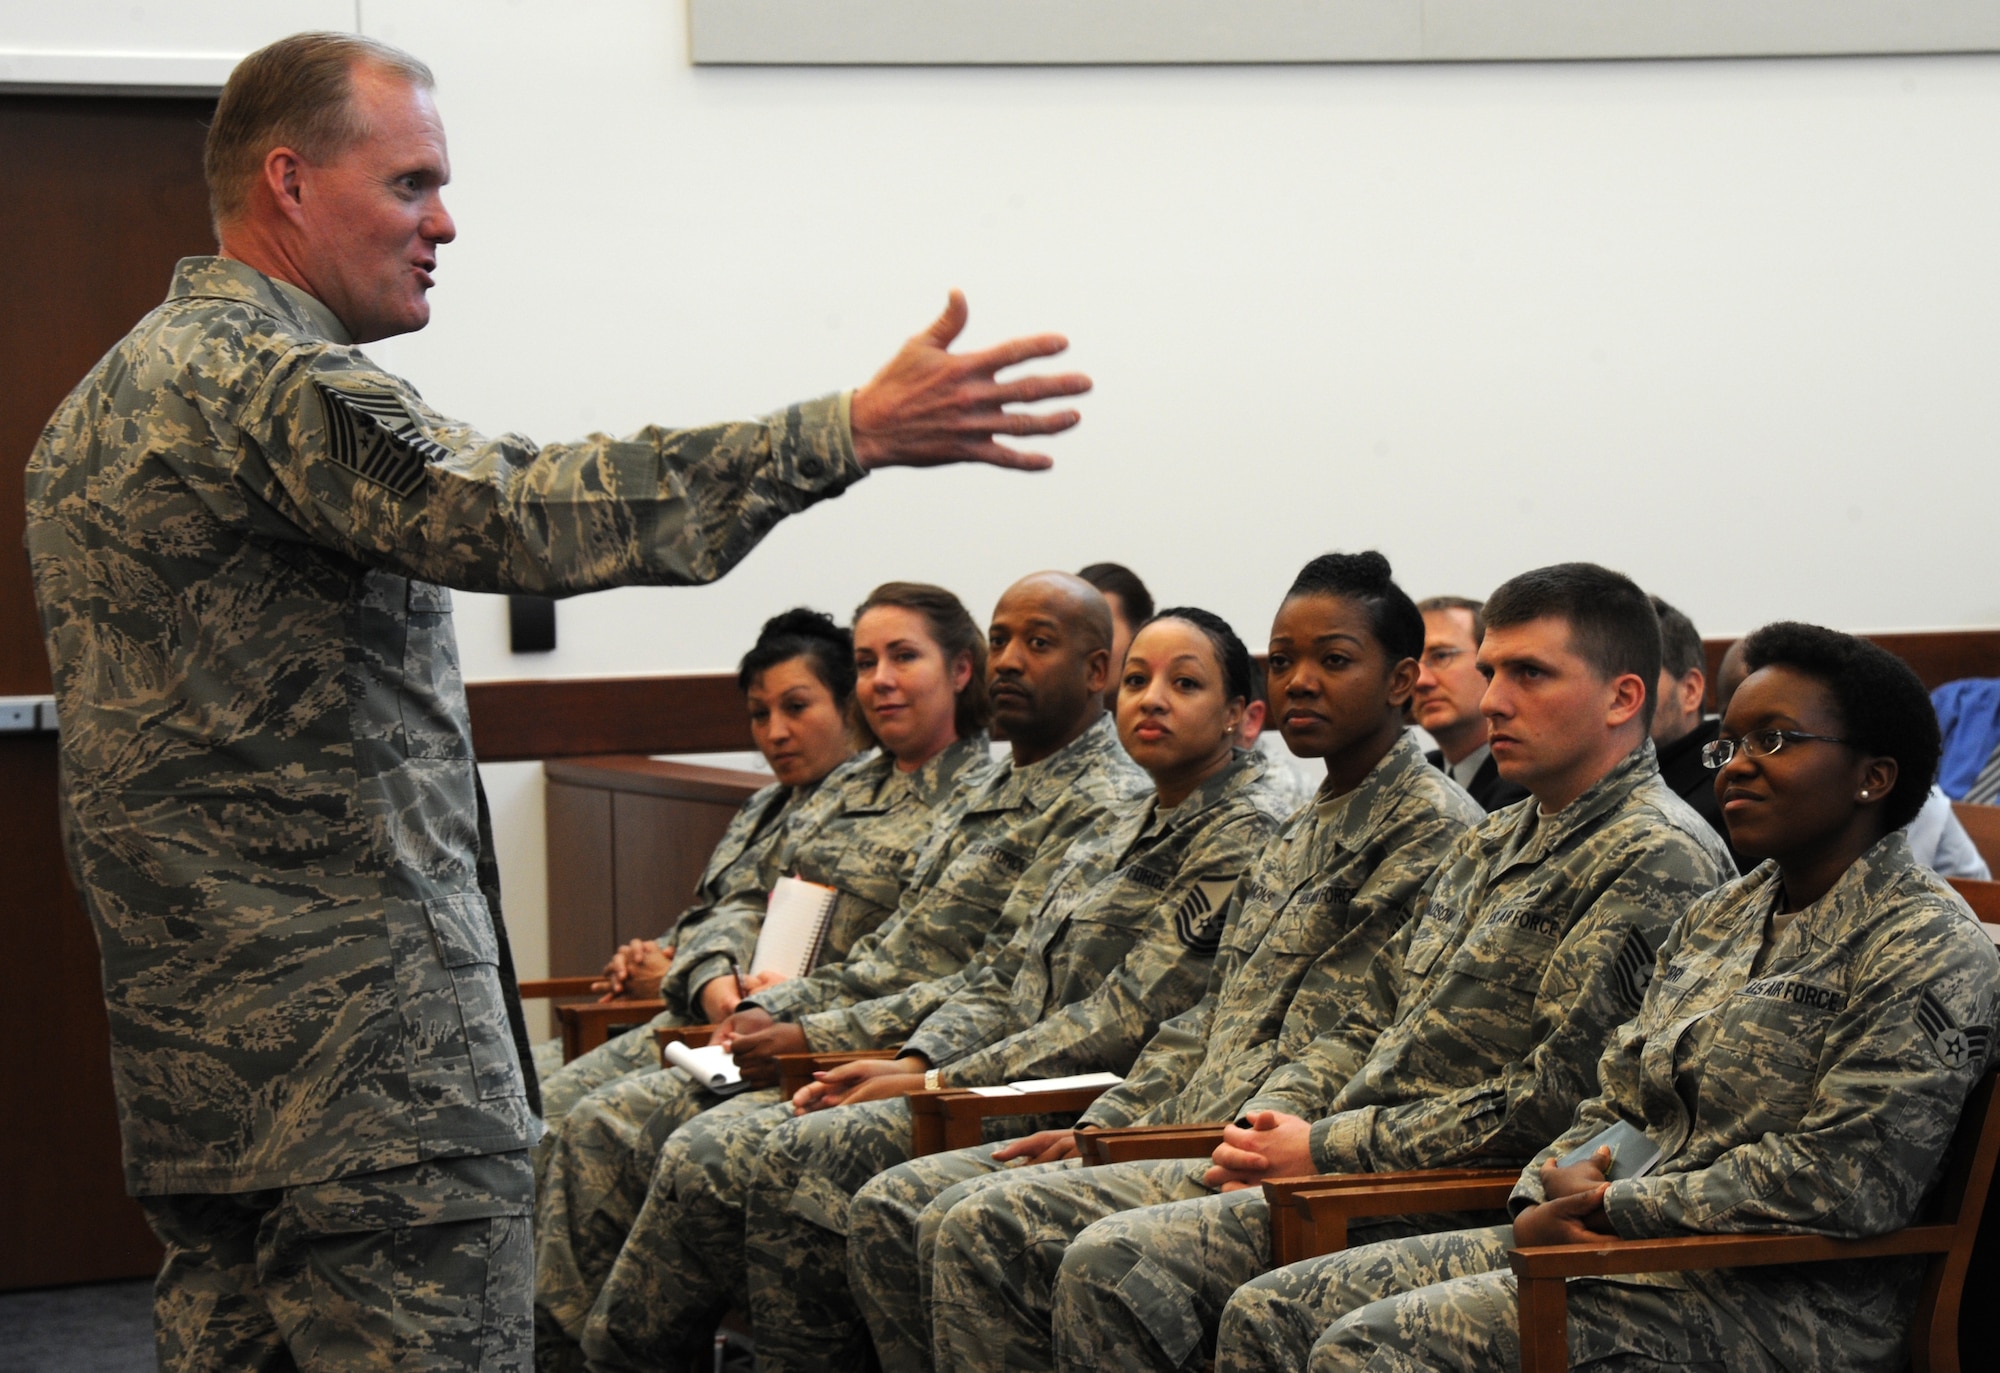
[668,731,994,1015]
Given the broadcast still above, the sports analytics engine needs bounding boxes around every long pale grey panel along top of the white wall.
[688,0,2000,66]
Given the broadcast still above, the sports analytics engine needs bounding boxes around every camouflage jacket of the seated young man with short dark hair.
[1248,741,1734,1173]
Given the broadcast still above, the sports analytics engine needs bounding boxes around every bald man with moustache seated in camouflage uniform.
[536,572,1146,1367]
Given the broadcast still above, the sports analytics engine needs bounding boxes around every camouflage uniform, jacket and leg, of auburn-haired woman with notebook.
[534,733,994,1345]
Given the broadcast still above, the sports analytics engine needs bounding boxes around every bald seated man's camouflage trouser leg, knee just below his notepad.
[580,1089,792,1371]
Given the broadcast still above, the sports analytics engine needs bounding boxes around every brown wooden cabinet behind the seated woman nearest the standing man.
[542,755,772,977]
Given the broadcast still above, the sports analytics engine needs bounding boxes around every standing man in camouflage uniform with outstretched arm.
[15,34,1086,1367]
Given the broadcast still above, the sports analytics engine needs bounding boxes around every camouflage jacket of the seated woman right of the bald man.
[908,753,1284,1087]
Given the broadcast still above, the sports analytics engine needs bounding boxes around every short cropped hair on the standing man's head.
[202,32,434,234]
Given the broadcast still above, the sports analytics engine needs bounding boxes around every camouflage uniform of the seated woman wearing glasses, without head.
[1216,833,2000,1373]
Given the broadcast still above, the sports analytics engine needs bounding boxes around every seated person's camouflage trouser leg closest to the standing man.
[534,1056,752,1369]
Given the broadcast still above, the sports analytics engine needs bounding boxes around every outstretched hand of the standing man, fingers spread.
[852,290,1090,470]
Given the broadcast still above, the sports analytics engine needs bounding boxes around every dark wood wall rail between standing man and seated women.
[466,672,754,763]
